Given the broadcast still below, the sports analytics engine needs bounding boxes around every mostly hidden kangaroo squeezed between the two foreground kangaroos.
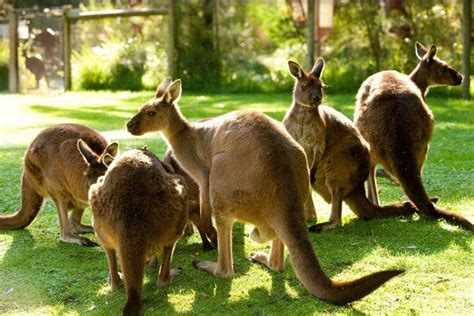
[163,150,214,250]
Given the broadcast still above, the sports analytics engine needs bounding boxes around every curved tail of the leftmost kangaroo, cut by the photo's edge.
[0,173,43,229]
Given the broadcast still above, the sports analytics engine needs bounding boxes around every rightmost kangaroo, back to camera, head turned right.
[354,42,473,231]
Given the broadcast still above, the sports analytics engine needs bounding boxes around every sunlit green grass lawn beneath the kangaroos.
[0,92,474,315]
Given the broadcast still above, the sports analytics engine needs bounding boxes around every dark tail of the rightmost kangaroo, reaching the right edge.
[395,154,474,231]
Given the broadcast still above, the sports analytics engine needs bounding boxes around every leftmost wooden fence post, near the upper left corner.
[8,6,20,93]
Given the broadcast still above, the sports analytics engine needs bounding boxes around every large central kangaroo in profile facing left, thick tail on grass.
[127,79,402,304]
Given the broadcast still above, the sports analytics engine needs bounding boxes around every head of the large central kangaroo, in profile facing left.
[127,78,181,135]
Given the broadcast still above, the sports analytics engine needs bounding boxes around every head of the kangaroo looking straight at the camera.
[288,57,324,107]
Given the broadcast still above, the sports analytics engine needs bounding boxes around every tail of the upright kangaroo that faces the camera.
[344,183,416,218]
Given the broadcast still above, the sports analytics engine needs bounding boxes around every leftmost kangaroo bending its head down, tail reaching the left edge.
[0,124,118,246]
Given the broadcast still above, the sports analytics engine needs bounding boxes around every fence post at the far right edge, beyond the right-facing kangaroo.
[462,0,472,100]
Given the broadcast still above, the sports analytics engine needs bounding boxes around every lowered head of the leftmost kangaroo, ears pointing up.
[77,139,118,185]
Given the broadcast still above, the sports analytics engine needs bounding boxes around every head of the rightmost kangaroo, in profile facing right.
[415,42,462,86]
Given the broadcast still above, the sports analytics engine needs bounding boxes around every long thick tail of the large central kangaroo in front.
[278,217,404,305]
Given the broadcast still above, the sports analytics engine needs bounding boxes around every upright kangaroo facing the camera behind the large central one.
[283,58,415,232]
